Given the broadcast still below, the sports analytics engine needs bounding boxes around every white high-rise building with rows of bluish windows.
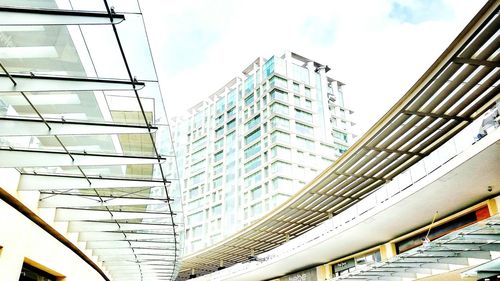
[173,52,354,253]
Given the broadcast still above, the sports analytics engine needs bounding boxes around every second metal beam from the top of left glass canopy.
[0,73,145,94]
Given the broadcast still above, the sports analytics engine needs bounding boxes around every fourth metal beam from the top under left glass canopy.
[0,148,165,168]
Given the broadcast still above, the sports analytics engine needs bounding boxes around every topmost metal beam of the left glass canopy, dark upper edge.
[0,7,125,26]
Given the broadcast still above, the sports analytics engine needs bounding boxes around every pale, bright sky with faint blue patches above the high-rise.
[140,0,485,136]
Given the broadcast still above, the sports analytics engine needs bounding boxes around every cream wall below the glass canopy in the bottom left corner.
[0,169,104,281]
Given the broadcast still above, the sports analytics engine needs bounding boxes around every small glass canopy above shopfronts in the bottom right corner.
[332,215,500,281]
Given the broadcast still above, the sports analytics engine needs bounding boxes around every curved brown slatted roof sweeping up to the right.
[180,1,500,279]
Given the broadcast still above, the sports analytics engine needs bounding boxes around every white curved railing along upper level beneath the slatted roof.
[192,104,499,280]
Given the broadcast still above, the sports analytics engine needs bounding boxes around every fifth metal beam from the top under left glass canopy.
[18,173,164,190]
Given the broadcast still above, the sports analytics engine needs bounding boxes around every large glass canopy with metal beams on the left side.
[0,0,183,280]
